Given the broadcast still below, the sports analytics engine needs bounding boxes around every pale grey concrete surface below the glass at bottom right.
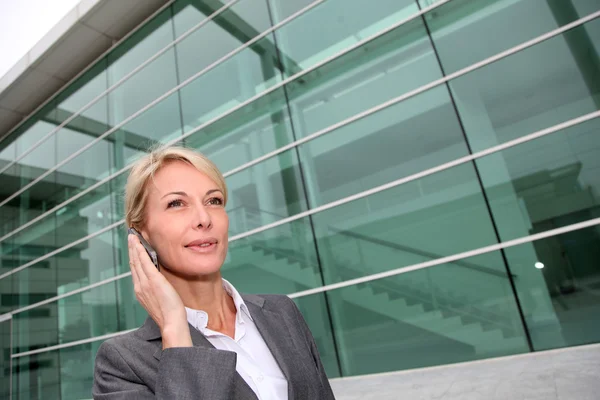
[331,344,600,400]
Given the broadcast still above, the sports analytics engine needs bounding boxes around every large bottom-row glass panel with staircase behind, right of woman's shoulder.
[328,253,528,375]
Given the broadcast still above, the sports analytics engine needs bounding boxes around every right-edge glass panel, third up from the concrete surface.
[450,20,600,155]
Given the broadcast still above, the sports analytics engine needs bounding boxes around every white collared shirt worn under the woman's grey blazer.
[185,279,288,400]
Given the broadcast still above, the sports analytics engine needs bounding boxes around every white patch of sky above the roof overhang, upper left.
[0,0,81,77]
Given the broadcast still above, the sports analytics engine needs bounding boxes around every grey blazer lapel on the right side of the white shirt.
[242,295,308,399]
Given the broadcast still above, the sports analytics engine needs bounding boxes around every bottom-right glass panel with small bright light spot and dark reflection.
[505,225,600,350]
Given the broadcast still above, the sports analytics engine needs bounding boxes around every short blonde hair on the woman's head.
[125,146,227,228]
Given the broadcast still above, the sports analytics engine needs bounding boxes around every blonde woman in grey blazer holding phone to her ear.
[93,147,334,400]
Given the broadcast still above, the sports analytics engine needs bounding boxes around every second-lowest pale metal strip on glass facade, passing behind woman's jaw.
[5,111,600,314]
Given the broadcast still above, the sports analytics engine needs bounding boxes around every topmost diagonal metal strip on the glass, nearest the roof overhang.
[0,0,240,174]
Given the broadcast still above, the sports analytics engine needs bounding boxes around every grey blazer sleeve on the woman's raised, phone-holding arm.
[92,342,236,400]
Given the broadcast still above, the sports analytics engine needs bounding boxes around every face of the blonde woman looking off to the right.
[141,161,229,277]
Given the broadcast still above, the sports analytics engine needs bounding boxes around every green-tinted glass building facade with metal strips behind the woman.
[0,0,600,399]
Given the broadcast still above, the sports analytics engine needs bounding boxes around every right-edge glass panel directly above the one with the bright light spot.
[477,118,600,241]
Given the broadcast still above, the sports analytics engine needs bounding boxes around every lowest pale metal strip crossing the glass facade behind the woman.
[11,218,600,358]
